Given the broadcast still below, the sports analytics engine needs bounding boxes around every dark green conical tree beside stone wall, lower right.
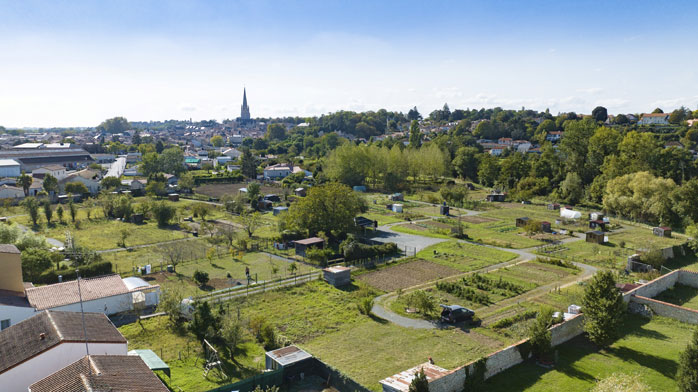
[582,270,625,347]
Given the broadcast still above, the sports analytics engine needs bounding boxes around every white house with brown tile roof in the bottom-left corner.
[0,311,128,392]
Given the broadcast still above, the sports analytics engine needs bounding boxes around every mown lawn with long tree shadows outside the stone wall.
[485,315,695,392]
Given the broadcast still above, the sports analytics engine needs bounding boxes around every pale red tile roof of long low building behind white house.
[26,274,129,310]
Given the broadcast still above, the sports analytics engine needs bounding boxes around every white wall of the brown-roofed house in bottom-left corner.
[0,342,128,392]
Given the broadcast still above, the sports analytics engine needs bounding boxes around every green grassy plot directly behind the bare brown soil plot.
[417,241,516,272]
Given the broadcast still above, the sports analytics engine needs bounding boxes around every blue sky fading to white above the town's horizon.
[0,0,698,127]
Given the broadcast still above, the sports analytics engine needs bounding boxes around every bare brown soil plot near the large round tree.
[357,260,460,292]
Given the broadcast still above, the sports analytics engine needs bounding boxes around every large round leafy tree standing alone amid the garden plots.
[288,183,364,237]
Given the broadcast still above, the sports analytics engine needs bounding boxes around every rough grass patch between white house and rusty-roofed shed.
[119,317,264,392]
